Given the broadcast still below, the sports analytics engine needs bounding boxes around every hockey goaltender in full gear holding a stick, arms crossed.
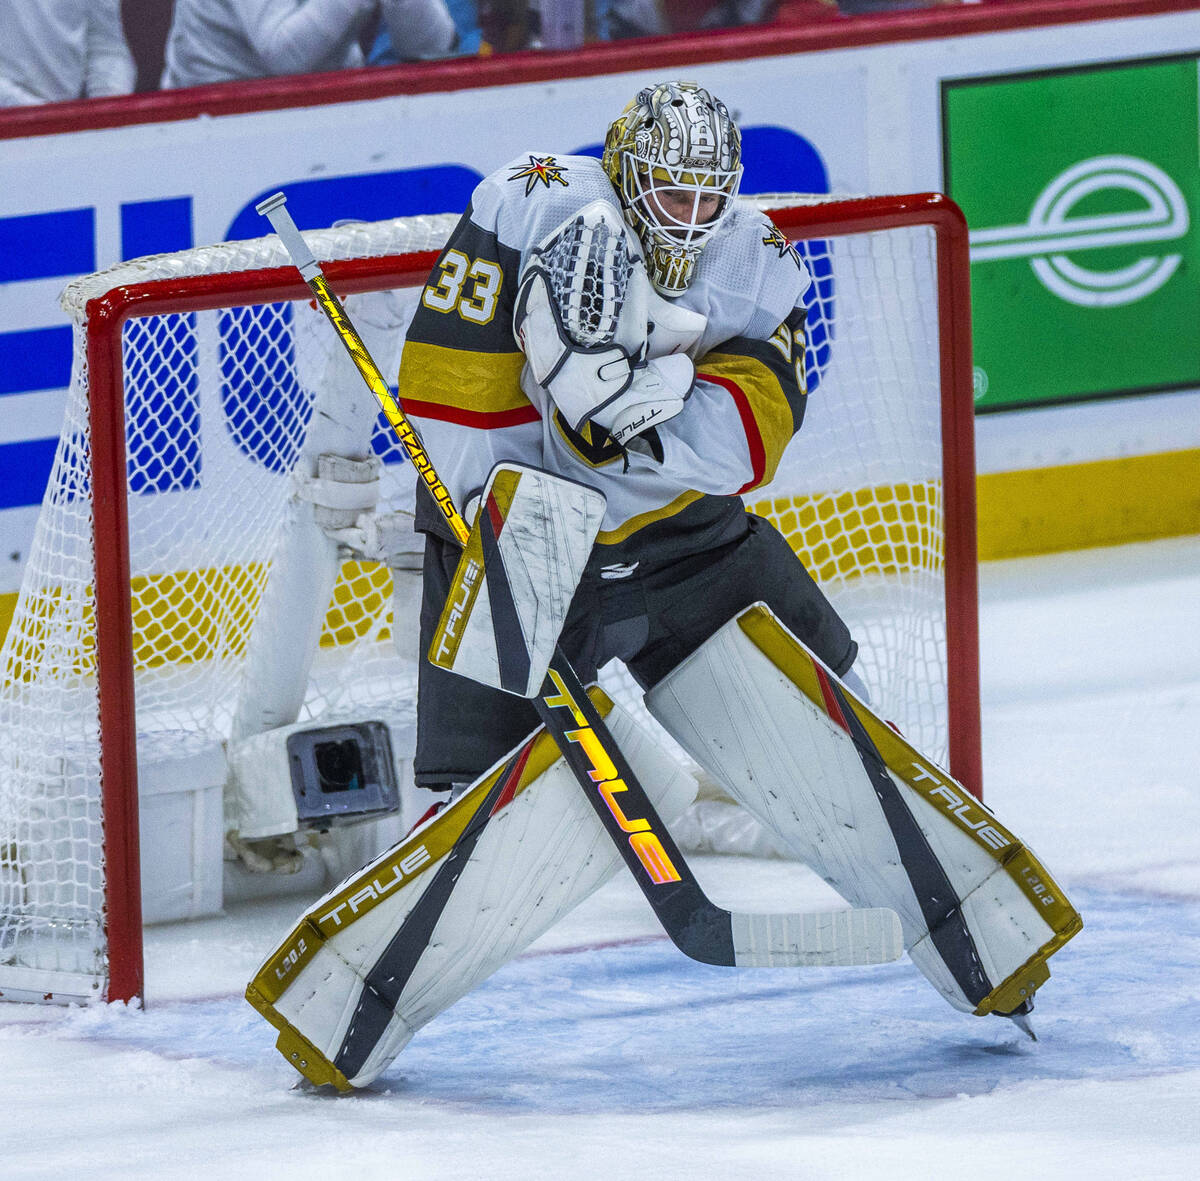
[247,82,1081,1091]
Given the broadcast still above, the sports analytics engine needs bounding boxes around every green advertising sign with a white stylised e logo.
[942,55,1200,412]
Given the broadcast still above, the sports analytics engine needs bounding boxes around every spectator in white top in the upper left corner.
[0,0,137,107]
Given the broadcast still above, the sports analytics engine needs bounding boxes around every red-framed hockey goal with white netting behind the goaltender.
[0,194,979,1001]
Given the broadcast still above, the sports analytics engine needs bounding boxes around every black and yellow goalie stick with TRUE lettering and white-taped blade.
[256,193,904,967]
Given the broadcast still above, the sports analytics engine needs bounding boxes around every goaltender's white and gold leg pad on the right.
[646,605,1081,1013]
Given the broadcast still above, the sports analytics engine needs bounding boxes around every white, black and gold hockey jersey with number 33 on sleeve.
[400,152,811,562]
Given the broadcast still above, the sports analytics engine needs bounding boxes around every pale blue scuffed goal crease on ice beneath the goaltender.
[0,892,1200,1115]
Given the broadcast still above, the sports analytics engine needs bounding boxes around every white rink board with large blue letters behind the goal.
[0,62,868,593]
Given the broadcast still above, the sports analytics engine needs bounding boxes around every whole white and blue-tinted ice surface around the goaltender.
[0,538,1200,1181]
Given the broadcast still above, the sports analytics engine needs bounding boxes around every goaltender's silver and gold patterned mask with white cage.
[604,82,742,296]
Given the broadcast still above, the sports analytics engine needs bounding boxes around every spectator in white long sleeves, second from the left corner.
[162,0,455,89]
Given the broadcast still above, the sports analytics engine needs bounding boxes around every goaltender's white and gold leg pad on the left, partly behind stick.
[246,690,696,1090]
